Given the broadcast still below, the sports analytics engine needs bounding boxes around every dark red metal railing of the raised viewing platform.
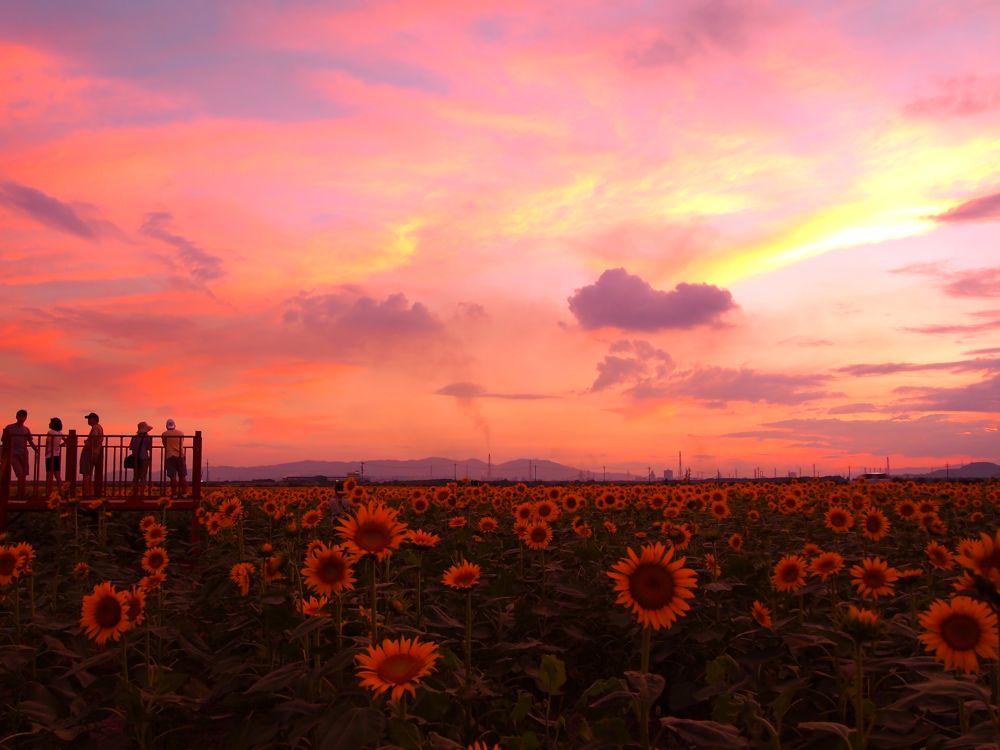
[0,430,202,530]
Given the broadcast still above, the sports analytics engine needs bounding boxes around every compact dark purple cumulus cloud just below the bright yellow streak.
[568,268,736,331]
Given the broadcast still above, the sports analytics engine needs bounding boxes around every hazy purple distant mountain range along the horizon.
[205,456,1000,482]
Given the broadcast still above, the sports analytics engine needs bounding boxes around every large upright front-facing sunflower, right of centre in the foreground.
[608,542,697,630]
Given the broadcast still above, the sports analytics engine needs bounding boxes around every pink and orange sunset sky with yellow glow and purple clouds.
[0,0,1000,474]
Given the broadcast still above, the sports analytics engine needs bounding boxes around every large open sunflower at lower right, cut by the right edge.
[918,596,997,672]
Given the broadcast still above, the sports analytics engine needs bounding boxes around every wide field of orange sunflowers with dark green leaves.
[0,480,1000,750]
